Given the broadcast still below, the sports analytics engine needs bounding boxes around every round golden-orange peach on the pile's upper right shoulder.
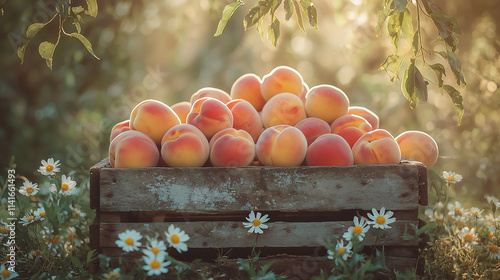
[305,85,349,124]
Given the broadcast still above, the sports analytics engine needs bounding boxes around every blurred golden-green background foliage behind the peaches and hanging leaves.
[0,0,500,201]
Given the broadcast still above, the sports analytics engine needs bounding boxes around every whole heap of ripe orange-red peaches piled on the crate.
[109,66,438,168]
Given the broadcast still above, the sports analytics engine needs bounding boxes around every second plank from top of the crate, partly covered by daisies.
[100,221,418,249]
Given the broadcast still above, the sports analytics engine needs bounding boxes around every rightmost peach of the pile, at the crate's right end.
[396,130,439,169]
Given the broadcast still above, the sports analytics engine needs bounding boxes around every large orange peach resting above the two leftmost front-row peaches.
[130,99,181,146]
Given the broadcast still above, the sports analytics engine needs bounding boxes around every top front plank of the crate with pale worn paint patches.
[99,164,421,213]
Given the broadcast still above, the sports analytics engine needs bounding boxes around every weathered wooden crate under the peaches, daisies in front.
[90,159,427,279]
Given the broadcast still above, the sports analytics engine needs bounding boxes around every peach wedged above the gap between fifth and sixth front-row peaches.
[330,115,372,148]
